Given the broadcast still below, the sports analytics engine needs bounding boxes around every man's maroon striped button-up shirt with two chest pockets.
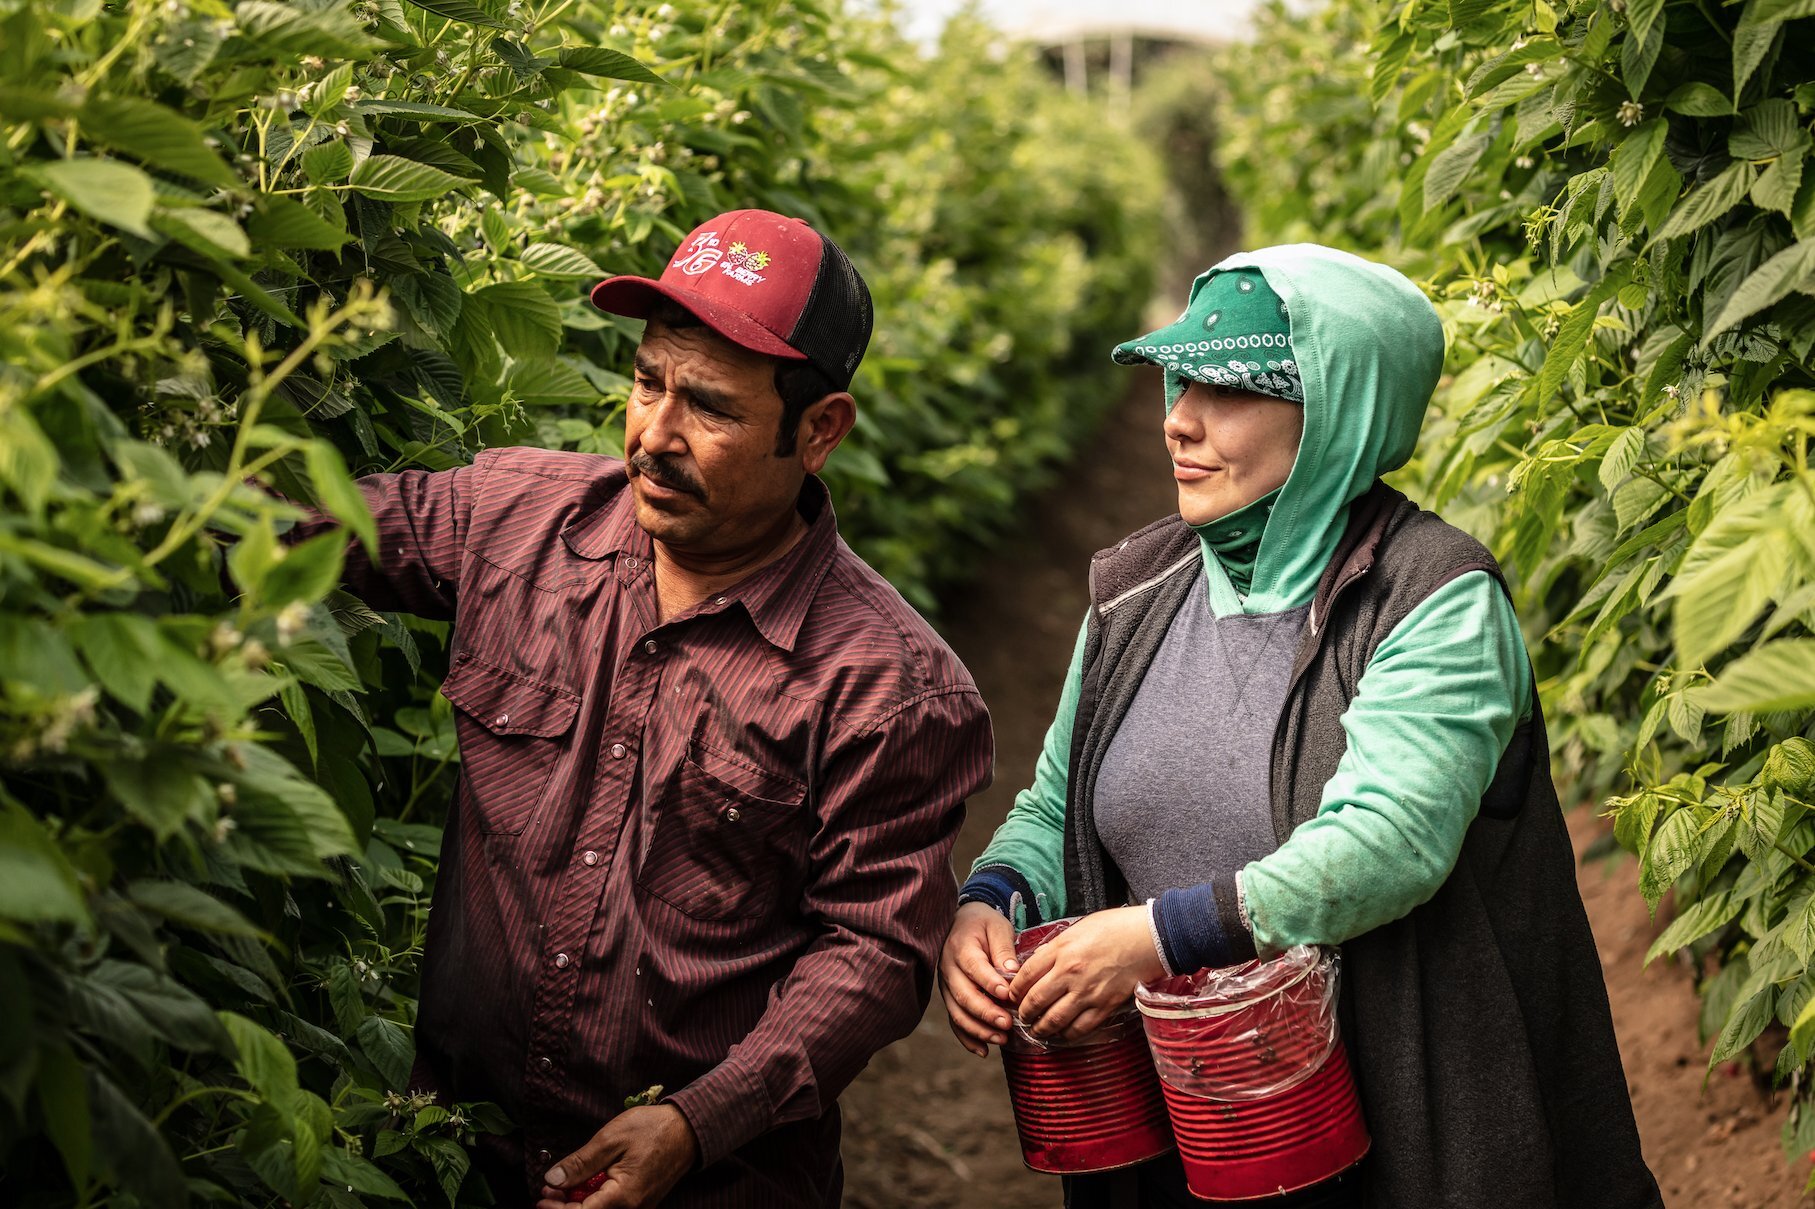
[315,448,993,1207]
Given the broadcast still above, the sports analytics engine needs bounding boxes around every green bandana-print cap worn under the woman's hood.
[1114,269,1305,408]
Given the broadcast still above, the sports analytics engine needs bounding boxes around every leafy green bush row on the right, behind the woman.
[1218,0,1815,1176]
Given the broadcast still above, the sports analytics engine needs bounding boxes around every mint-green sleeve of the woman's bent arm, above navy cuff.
[1240,572,1532,953]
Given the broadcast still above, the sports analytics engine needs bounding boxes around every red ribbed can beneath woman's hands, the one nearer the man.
[1002,919,1172,1175]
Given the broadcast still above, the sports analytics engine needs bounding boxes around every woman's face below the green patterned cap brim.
[1165,381,1305,525]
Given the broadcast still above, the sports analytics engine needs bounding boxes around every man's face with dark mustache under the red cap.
[624,319,806,555]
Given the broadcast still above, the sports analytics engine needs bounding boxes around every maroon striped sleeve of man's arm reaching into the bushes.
[283,454,485,621]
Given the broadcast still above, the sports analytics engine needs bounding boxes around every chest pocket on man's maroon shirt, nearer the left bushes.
[441,654,579,835]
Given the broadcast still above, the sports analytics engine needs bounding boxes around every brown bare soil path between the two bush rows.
[842,376,1808,1209]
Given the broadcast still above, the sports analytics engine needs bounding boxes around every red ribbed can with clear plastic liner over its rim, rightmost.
[1134,946,1369,1200]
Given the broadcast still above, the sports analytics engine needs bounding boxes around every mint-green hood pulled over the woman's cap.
[1191,243,1443,615]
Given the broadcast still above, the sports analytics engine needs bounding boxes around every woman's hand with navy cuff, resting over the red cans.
[1009,906,1165,1042]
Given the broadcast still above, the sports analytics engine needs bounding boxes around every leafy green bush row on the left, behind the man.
[0,0,1156,1209]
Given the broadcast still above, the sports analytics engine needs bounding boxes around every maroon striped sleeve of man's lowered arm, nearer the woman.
[668,684,995,1165]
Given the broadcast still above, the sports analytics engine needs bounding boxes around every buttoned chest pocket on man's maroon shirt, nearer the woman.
[637,742,809,920]
